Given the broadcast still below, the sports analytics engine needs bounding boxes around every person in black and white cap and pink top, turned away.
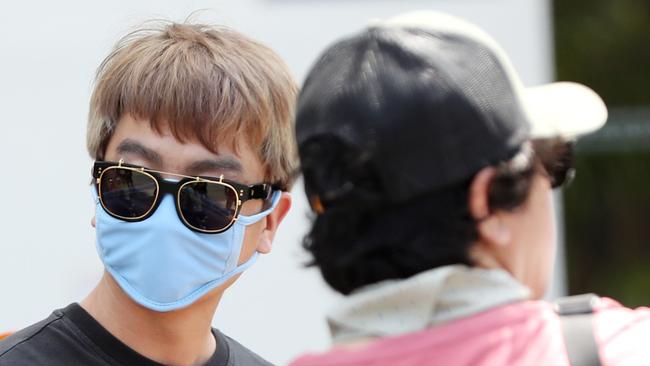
[292,12,650,366]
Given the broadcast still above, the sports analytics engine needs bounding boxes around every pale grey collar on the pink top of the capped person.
[327,265,530,343]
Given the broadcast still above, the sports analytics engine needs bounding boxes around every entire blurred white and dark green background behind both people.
[0,0,650,365]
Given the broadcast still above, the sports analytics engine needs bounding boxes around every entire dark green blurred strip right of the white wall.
[554,0,650,307]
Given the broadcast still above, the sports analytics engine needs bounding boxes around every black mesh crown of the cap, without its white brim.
[296,28,529,206]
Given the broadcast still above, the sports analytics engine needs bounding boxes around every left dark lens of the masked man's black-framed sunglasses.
[99,167,158,220]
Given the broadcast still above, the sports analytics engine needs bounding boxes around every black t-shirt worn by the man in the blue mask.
[0,304,271,366]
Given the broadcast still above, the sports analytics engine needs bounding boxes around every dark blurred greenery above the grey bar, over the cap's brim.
[554,0,650,106]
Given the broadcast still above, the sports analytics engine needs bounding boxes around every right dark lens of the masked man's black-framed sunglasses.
[178,182,237,232]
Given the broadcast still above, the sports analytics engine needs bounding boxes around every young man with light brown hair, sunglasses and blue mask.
[0,23,296,366]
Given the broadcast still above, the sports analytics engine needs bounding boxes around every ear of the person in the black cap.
[468,167,511,246]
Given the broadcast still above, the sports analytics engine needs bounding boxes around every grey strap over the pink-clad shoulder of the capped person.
[554,294,602,366]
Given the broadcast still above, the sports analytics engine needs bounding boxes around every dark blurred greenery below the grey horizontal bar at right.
[564,151,650,306]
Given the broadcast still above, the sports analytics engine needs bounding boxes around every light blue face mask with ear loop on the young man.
[93,189,280,312]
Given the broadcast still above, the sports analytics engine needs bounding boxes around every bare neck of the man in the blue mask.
[80,272,223,365]
